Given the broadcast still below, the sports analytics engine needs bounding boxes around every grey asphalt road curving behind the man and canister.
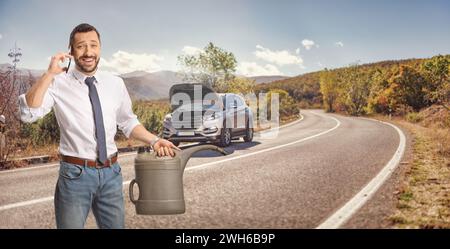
[0,110,399,228]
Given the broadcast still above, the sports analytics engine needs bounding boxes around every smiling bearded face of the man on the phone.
[72,31,100,75]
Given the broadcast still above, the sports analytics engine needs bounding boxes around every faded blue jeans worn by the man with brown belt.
[55,161,125,228]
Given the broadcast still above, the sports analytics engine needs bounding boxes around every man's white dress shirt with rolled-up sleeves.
[19,69,139,160]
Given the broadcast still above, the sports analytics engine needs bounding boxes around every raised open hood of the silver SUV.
[169,83,222,110]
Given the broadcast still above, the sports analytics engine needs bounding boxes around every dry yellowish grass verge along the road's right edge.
[388,121,450,228]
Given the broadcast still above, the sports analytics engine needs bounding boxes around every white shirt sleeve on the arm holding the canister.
[117,81,140,138]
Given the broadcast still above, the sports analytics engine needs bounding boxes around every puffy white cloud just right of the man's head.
[99,50,164,74]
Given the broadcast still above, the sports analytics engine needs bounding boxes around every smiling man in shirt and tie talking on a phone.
[19,23,178,228]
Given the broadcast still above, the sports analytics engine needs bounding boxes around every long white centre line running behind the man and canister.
[0,113,316,211]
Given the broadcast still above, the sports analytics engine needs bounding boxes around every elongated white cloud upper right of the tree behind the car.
[254,45,303,66]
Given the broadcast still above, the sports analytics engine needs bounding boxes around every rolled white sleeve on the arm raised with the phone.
[19,84,55,123]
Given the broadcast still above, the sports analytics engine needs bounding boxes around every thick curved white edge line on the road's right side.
[317,118,406,229]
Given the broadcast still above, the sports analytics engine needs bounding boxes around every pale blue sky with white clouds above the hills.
[0,0,450,76]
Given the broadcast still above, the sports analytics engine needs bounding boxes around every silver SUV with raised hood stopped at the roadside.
[163,83,253,147]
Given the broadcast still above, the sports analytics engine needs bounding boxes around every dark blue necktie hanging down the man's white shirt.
[84,76,108,164]
